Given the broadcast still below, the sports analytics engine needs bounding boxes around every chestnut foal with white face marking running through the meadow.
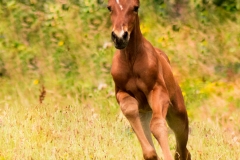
[108,0,191,160]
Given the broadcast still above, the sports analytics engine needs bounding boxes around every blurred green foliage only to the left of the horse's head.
[0,0,110,92]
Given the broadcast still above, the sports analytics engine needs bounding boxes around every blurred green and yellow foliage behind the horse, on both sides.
[0,0,240,105]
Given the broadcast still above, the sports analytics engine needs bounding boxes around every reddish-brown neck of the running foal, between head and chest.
[121,17,143,63]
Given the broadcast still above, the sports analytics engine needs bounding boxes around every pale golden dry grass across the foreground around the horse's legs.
[0,82,240,160]
